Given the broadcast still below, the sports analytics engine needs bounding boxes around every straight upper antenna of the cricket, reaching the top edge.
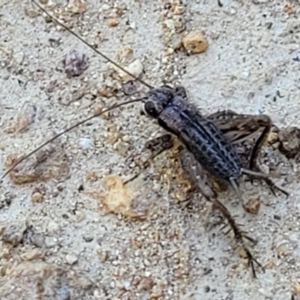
[31,0,153,89]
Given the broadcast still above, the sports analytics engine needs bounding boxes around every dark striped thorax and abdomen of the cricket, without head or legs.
[158,105,242,181]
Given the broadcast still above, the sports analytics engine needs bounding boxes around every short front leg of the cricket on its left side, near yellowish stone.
[124,134,174,184]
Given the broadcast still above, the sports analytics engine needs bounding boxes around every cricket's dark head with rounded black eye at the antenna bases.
[143,85,175,119]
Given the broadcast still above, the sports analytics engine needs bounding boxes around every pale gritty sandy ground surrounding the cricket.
[0,0,300,300]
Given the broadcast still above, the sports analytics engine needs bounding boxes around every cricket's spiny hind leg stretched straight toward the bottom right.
[180,148,264,278]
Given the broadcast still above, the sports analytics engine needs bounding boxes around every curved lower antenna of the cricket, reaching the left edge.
[0,97,145,183]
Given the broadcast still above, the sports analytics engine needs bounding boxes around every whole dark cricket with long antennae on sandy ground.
[1,0,288,277]
